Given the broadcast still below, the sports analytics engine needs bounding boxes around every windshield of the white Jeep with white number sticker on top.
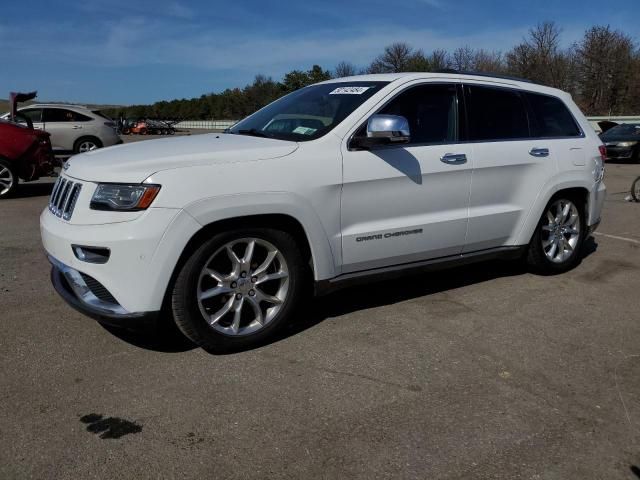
[227,82,388,141]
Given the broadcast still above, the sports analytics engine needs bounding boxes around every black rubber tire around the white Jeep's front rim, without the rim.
[171,228,307,352]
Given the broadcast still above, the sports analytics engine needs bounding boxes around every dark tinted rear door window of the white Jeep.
[465,85,530,142]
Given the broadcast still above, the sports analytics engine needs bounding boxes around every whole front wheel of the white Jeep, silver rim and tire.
[172,228,304,350]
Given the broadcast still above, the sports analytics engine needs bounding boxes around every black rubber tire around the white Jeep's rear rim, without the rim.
[526,192,588,275]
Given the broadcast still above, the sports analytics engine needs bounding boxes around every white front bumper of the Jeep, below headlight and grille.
[40,206,201,318]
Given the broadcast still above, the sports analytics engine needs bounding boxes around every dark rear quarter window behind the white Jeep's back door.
[525,92,582,138]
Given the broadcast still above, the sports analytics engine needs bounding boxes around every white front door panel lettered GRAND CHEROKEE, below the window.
[342,145,471,272]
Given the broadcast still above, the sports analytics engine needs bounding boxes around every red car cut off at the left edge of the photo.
[0,92,56,199]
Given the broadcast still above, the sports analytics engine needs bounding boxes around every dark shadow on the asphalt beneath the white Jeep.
[103,237,598,355]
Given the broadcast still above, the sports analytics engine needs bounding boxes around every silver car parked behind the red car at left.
[7,103,122,155]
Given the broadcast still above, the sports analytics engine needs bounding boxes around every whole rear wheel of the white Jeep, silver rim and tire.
[527,198,585,273]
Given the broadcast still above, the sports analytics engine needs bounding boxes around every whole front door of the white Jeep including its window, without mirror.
[341,85,473,273]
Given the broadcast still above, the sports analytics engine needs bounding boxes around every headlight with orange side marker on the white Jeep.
[91,183,160,212]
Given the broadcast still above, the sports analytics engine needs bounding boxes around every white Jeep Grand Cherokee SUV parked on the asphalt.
[40,73,606,349]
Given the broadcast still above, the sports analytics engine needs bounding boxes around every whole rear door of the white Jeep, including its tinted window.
[464,85,557,252]
